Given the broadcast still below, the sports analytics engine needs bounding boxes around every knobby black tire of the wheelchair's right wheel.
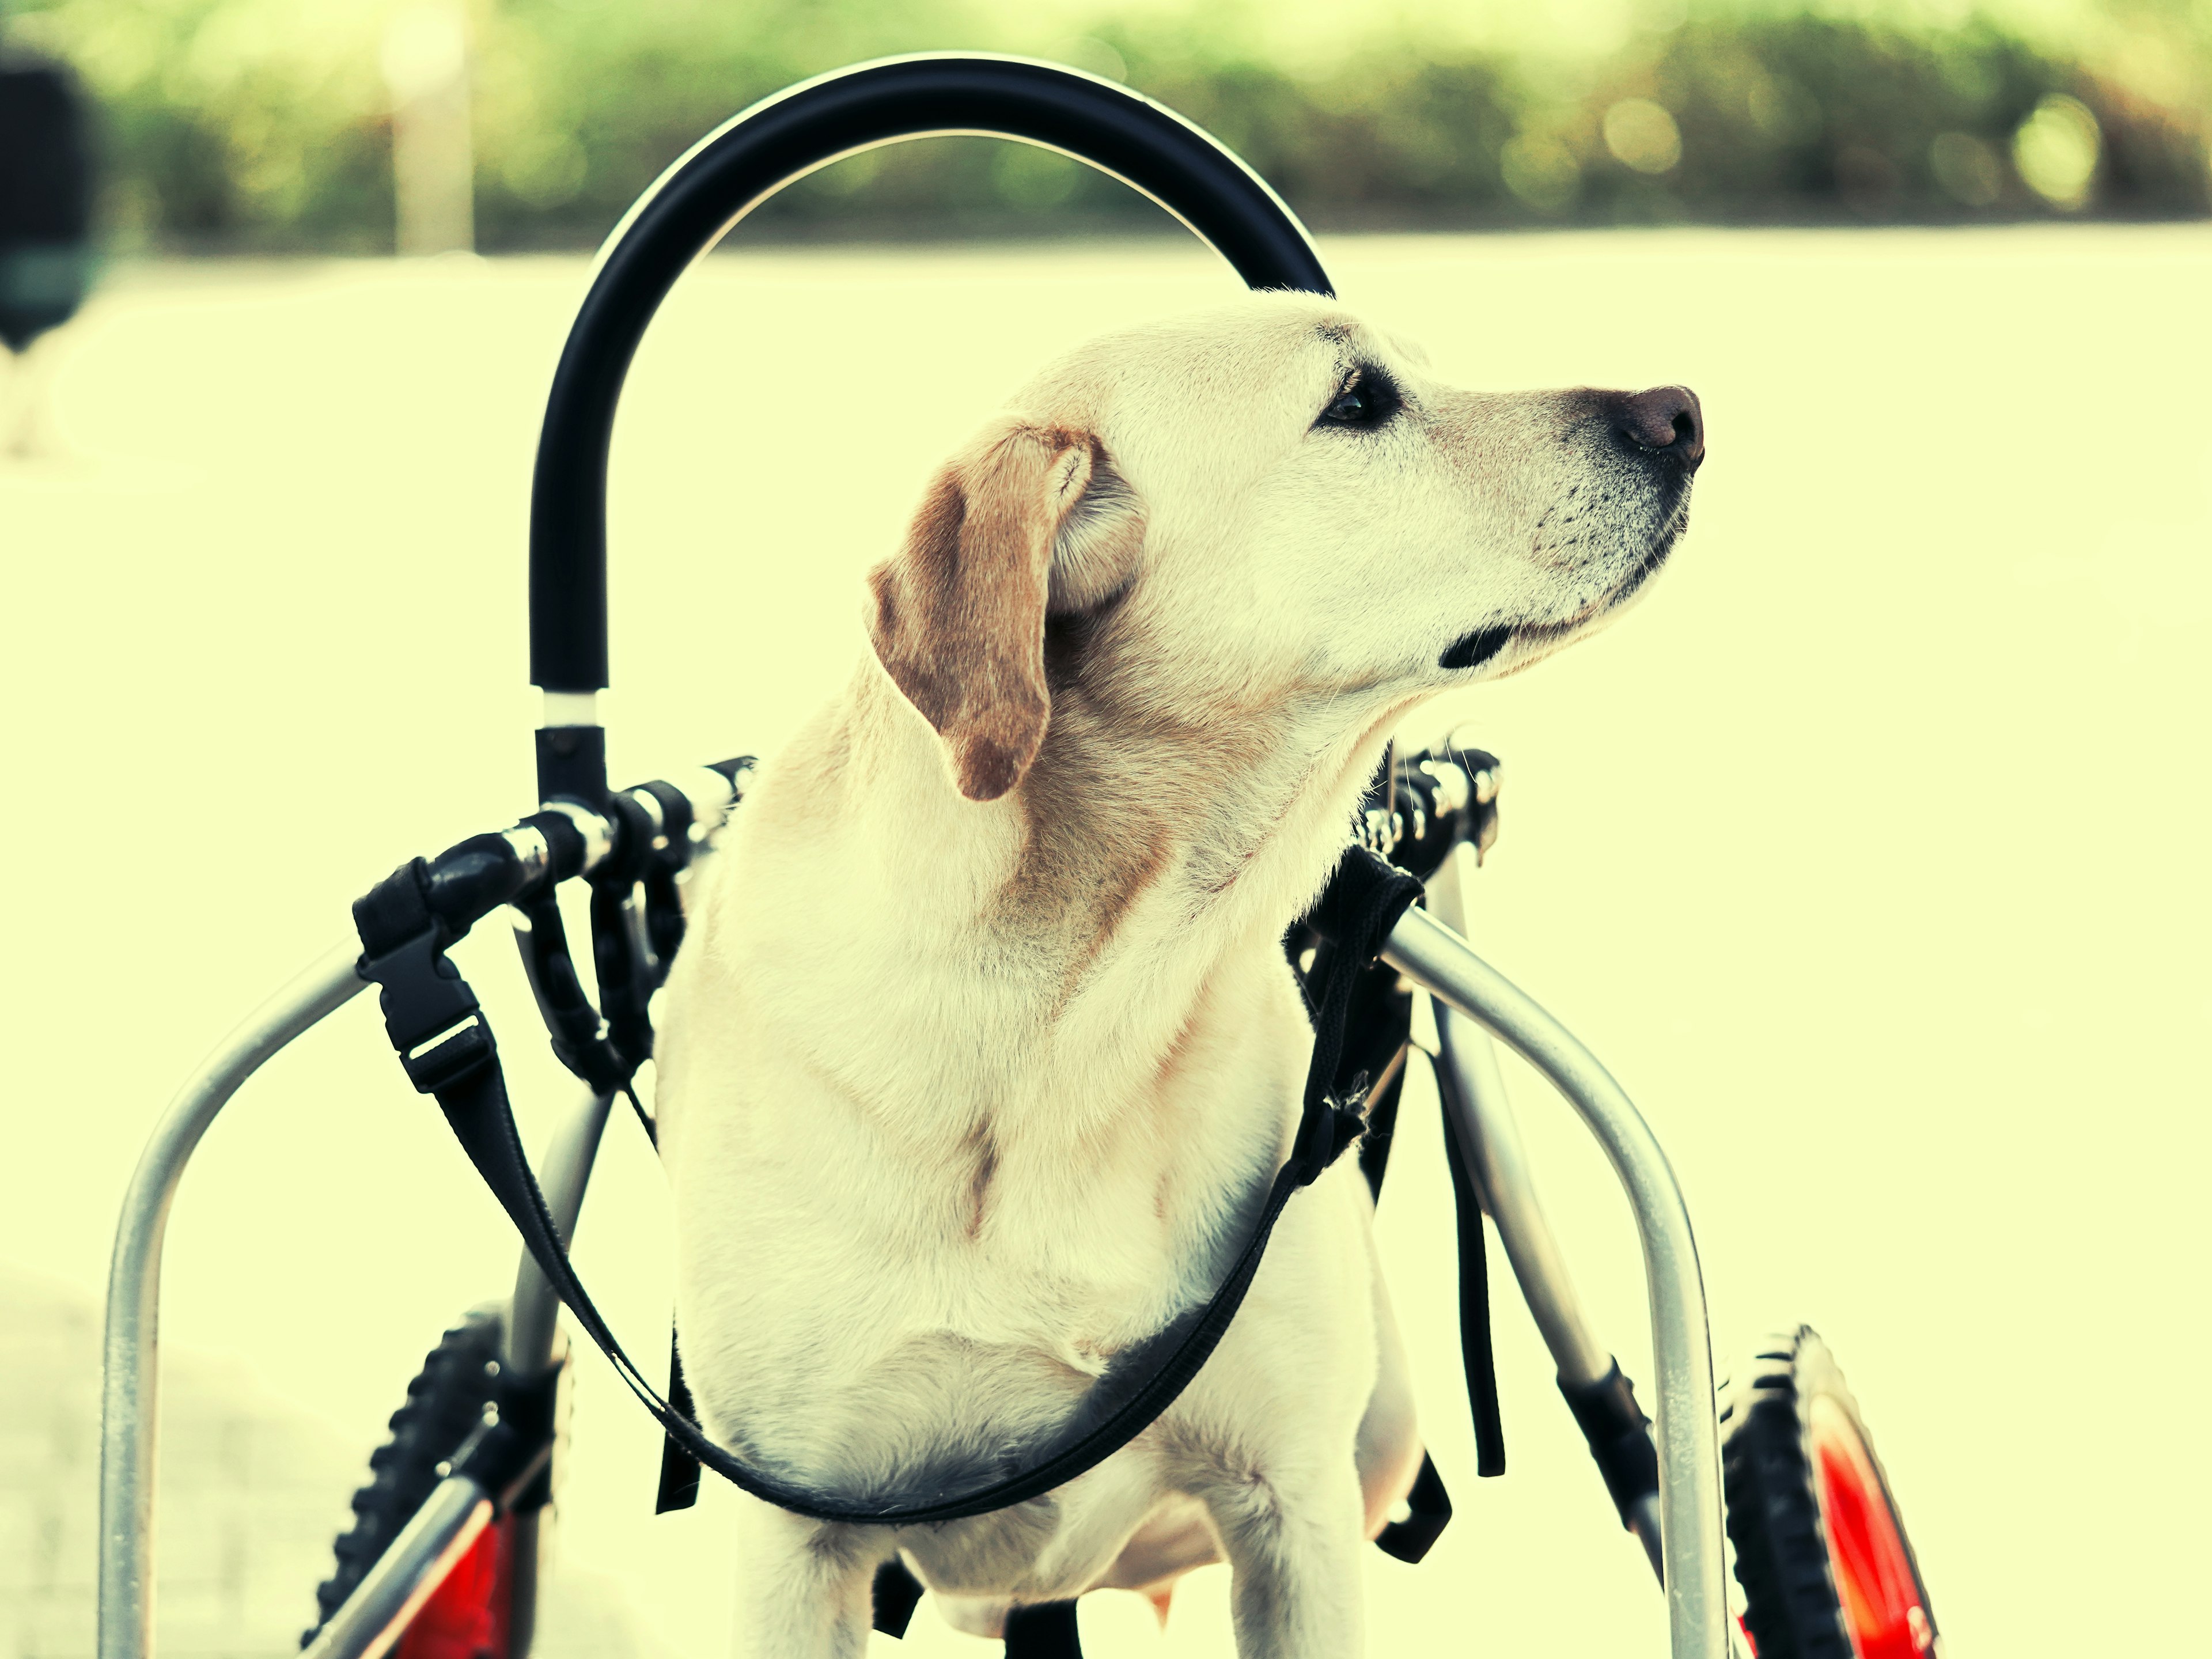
[1721,1325,1942,1659]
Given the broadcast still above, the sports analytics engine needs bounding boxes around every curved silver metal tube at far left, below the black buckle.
[100,940,367,1659]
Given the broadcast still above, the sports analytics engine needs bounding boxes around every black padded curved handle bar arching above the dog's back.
[531,55,1334,752]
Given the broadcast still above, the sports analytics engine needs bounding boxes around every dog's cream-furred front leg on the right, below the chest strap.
[1203,1458,1365,1659]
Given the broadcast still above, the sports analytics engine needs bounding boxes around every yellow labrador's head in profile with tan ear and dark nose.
[869,294,1703,801]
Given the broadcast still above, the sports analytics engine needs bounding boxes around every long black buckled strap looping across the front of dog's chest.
[354,847,1420,1527]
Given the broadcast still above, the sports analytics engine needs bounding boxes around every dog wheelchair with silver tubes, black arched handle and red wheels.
[100,58,1940,1659]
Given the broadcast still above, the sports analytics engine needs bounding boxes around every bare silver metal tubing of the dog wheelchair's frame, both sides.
[100,880,1730,1659]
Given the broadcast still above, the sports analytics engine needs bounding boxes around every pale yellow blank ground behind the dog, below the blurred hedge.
[0,226,2212,1659]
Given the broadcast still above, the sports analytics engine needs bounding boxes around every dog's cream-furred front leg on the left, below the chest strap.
[734,1498,892,1659]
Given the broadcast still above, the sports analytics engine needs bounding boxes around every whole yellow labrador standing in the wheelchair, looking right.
[659,294,1703,1659]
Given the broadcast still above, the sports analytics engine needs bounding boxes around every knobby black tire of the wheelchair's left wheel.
[298,1307,505,1648]
